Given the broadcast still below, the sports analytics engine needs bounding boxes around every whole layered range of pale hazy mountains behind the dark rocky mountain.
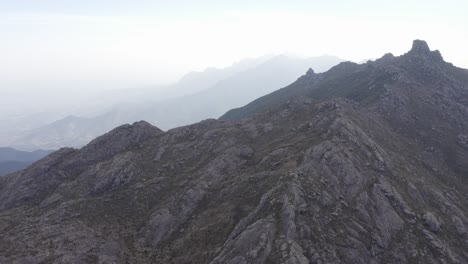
[10,55,342,150]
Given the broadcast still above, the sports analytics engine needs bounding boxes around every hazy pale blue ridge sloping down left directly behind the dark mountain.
[133,55,341,129]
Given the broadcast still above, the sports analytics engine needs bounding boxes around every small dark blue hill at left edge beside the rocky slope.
[0,148,52,176]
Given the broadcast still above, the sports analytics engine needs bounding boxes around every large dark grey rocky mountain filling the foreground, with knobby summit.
[0,41,468,264]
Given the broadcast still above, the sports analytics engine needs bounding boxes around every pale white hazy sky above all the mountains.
[0,0,468,89]
